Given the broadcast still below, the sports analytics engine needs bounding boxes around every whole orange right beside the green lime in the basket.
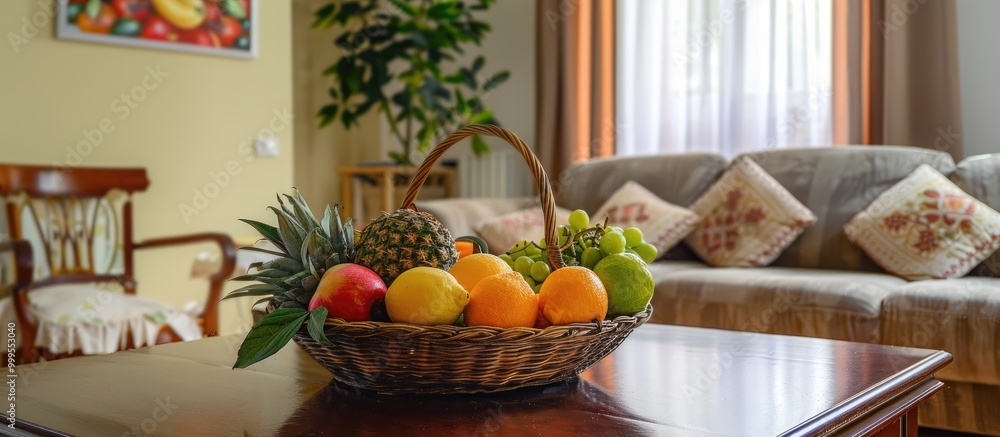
[538,266,608,325]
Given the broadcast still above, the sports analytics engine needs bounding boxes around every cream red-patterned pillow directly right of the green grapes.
[591,181,698,259]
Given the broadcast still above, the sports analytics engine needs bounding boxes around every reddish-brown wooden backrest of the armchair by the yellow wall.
[0,164,149,293]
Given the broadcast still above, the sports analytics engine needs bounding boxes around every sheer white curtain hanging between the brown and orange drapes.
[616,0,833,157]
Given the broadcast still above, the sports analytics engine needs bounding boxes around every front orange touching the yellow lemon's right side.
[465,270,538,328]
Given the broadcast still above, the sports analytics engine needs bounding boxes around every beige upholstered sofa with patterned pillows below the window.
[418,146,1000,435]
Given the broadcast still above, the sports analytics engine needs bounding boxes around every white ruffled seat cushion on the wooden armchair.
[0,284,201,355]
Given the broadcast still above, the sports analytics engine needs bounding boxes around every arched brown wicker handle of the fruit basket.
[400,124,566,269]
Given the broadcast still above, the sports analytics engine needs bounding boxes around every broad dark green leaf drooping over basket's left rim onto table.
[233,308,309,369]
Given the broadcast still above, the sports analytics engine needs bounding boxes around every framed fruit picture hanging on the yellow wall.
[56,0,257,58]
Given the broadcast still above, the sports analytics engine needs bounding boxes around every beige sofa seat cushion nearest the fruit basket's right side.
[653,264,905,342]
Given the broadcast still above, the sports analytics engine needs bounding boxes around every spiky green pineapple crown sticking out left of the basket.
[226,189,354,309]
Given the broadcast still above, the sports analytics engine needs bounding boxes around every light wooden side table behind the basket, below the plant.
[337,165,454,217]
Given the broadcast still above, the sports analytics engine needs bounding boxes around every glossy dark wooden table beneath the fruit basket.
[0,324,951,436]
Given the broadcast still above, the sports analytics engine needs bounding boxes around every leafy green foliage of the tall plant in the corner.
[313,0,510,165]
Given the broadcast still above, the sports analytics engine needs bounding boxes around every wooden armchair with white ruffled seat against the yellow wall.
[0,164,236,362]
